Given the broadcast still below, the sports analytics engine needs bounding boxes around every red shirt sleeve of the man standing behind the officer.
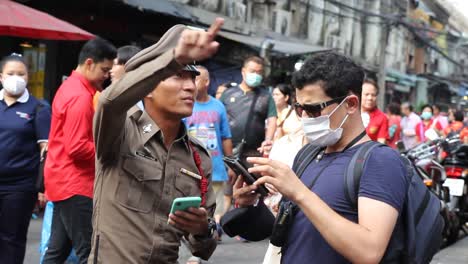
[63,96,94,160]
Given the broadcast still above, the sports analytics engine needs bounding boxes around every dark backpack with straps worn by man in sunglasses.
[293,141,444,264]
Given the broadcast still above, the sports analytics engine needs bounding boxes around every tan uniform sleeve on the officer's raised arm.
[94,49,182,161]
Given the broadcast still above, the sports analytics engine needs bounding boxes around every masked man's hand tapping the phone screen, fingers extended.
[247,157,308,202]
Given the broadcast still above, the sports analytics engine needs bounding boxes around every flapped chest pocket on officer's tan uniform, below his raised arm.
[116,156,162,213]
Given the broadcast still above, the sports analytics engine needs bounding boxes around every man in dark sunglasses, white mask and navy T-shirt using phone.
[234,52,408,264]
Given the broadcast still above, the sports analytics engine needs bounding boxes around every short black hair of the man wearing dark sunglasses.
[292,52,364,100]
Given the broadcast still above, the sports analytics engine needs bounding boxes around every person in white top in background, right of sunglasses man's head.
[400,102,421,149]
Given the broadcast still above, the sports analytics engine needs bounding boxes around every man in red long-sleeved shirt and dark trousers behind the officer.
[43,38,116,264]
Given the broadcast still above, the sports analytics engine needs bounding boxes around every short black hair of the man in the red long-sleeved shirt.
[78,37,117,65]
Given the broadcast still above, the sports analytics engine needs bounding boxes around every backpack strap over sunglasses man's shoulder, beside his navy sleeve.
[344,141,386,211]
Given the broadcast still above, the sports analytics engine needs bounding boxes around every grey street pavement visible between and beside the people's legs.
[24,218,468,264]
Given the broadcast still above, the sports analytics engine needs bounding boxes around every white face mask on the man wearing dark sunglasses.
[301,98,348,147]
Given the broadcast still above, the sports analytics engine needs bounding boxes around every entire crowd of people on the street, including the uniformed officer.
[0,19,468,264]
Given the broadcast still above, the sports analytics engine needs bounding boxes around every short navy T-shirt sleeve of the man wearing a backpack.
[359,147,408,212]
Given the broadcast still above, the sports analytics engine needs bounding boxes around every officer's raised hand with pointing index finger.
[174,18,224,65]
